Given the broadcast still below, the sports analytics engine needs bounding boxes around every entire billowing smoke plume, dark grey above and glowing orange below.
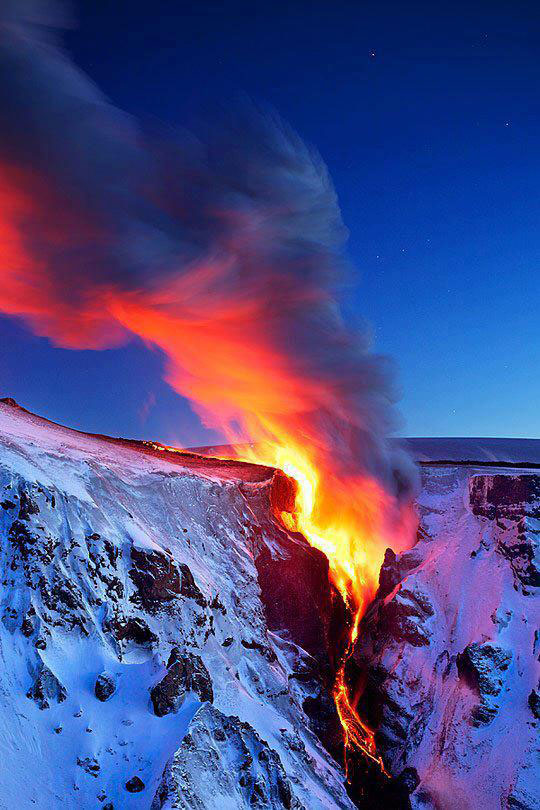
[0,2,416,607]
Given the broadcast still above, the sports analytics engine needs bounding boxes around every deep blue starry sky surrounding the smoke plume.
[0,0,540,444]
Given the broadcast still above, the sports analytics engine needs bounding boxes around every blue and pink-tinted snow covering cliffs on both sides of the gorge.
[0,403,540,810]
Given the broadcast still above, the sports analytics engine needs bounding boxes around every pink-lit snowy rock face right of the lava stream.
[350,465,540,810]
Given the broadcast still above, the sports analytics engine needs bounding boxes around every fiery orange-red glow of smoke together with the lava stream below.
[0,163,416,764]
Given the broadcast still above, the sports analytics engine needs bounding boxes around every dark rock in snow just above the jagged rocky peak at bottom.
[150,648,214,717]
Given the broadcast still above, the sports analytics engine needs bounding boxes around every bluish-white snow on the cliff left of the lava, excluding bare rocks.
[0,403,352,810]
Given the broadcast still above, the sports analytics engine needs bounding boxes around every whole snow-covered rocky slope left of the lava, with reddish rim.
[0,404,352,810]
